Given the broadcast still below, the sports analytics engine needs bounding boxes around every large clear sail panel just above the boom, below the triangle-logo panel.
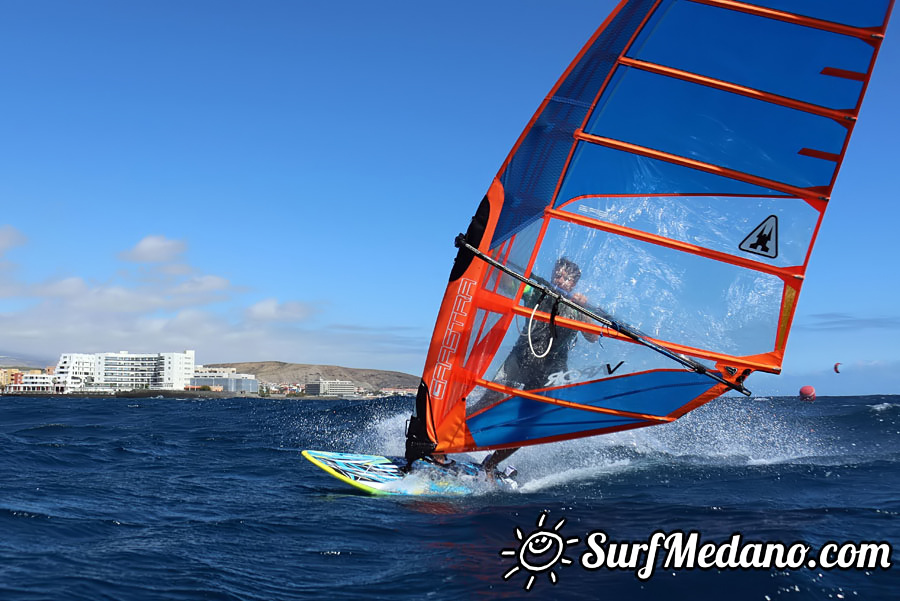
[536,220,784,356]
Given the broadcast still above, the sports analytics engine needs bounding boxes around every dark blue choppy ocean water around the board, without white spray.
[0,396,900,601]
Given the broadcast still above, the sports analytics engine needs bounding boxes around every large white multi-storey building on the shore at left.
[54,351,194,392]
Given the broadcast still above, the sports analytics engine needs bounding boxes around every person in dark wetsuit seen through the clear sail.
[480,257,599,472]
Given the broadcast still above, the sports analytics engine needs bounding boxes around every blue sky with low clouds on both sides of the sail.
[0,0,900,394]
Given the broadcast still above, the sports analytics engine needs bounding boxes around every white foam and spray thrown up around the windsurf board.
[367,398,832,493]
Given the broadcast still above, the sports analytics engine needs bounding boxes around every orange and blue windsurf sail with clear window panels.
[407,0,893,459]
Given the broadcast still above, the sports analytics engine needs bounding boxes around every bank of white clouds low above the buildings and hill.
[0,228,428,373]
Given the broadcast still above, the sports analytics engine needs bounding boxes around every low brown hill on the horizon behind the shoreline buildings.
[206,361,419,390]
